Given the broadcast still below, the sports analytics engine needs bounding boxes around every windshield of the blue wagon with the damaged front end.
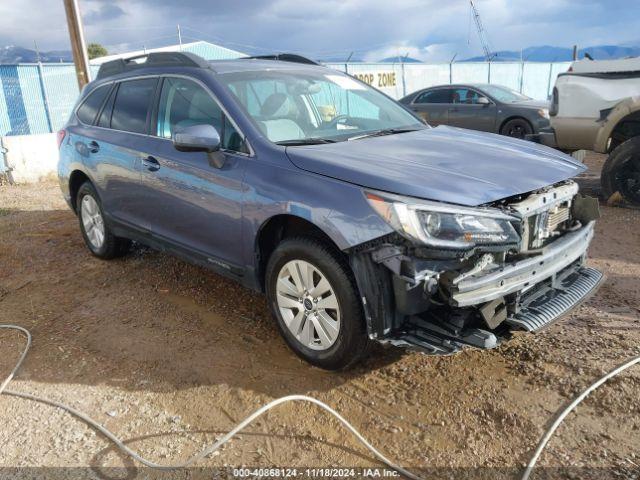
[218,68,428,145]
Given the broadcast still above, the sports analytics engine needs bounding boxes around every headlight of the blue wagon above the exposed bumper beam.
[365,192,520,249]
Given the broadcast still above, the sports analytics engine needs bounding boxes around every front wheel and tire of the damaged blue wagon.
[266,237,370,370]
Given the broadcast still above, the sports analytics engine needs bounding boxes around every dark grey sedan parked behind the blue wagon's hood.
[400,84,549,138]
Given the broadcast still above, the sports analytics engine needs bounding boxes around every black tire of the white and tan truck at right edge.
[600,137,640,205]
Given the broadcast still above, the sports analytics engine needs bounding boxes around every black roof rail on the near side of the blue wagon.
[96,52,210,80]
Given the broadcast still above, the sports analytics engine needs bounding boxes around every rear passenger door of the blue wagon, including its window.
[76,77,158,232]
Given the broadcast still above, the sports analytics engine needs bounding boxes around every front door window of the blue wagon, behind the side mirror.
[157,78,246,153]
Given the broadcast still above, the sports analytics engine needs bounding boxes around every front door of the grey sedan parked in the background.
[449,87,498,132]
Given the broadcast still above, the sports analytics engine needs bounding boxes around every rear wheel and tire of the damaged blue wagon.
[76,182,131,260]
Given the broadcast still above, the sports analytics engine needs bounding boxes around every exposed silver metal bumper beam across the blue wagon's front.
[450,221,595,307]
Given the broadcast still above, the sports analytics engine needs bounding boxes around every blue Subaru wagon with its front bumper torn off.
[58,53,602,369]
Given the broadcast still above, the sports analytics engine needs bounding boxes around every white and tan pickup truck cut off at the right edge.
[539,58,640,204]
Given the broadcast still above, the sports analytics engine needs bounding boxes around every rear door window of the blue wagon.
[111,78,157,133]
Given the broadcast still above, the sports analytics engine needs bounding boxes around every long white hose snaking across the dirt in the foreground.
[0,325,640,480]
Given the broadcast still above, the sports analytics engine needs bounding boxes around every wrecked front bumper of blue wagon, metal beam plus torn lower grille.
[377,221,604,355]
